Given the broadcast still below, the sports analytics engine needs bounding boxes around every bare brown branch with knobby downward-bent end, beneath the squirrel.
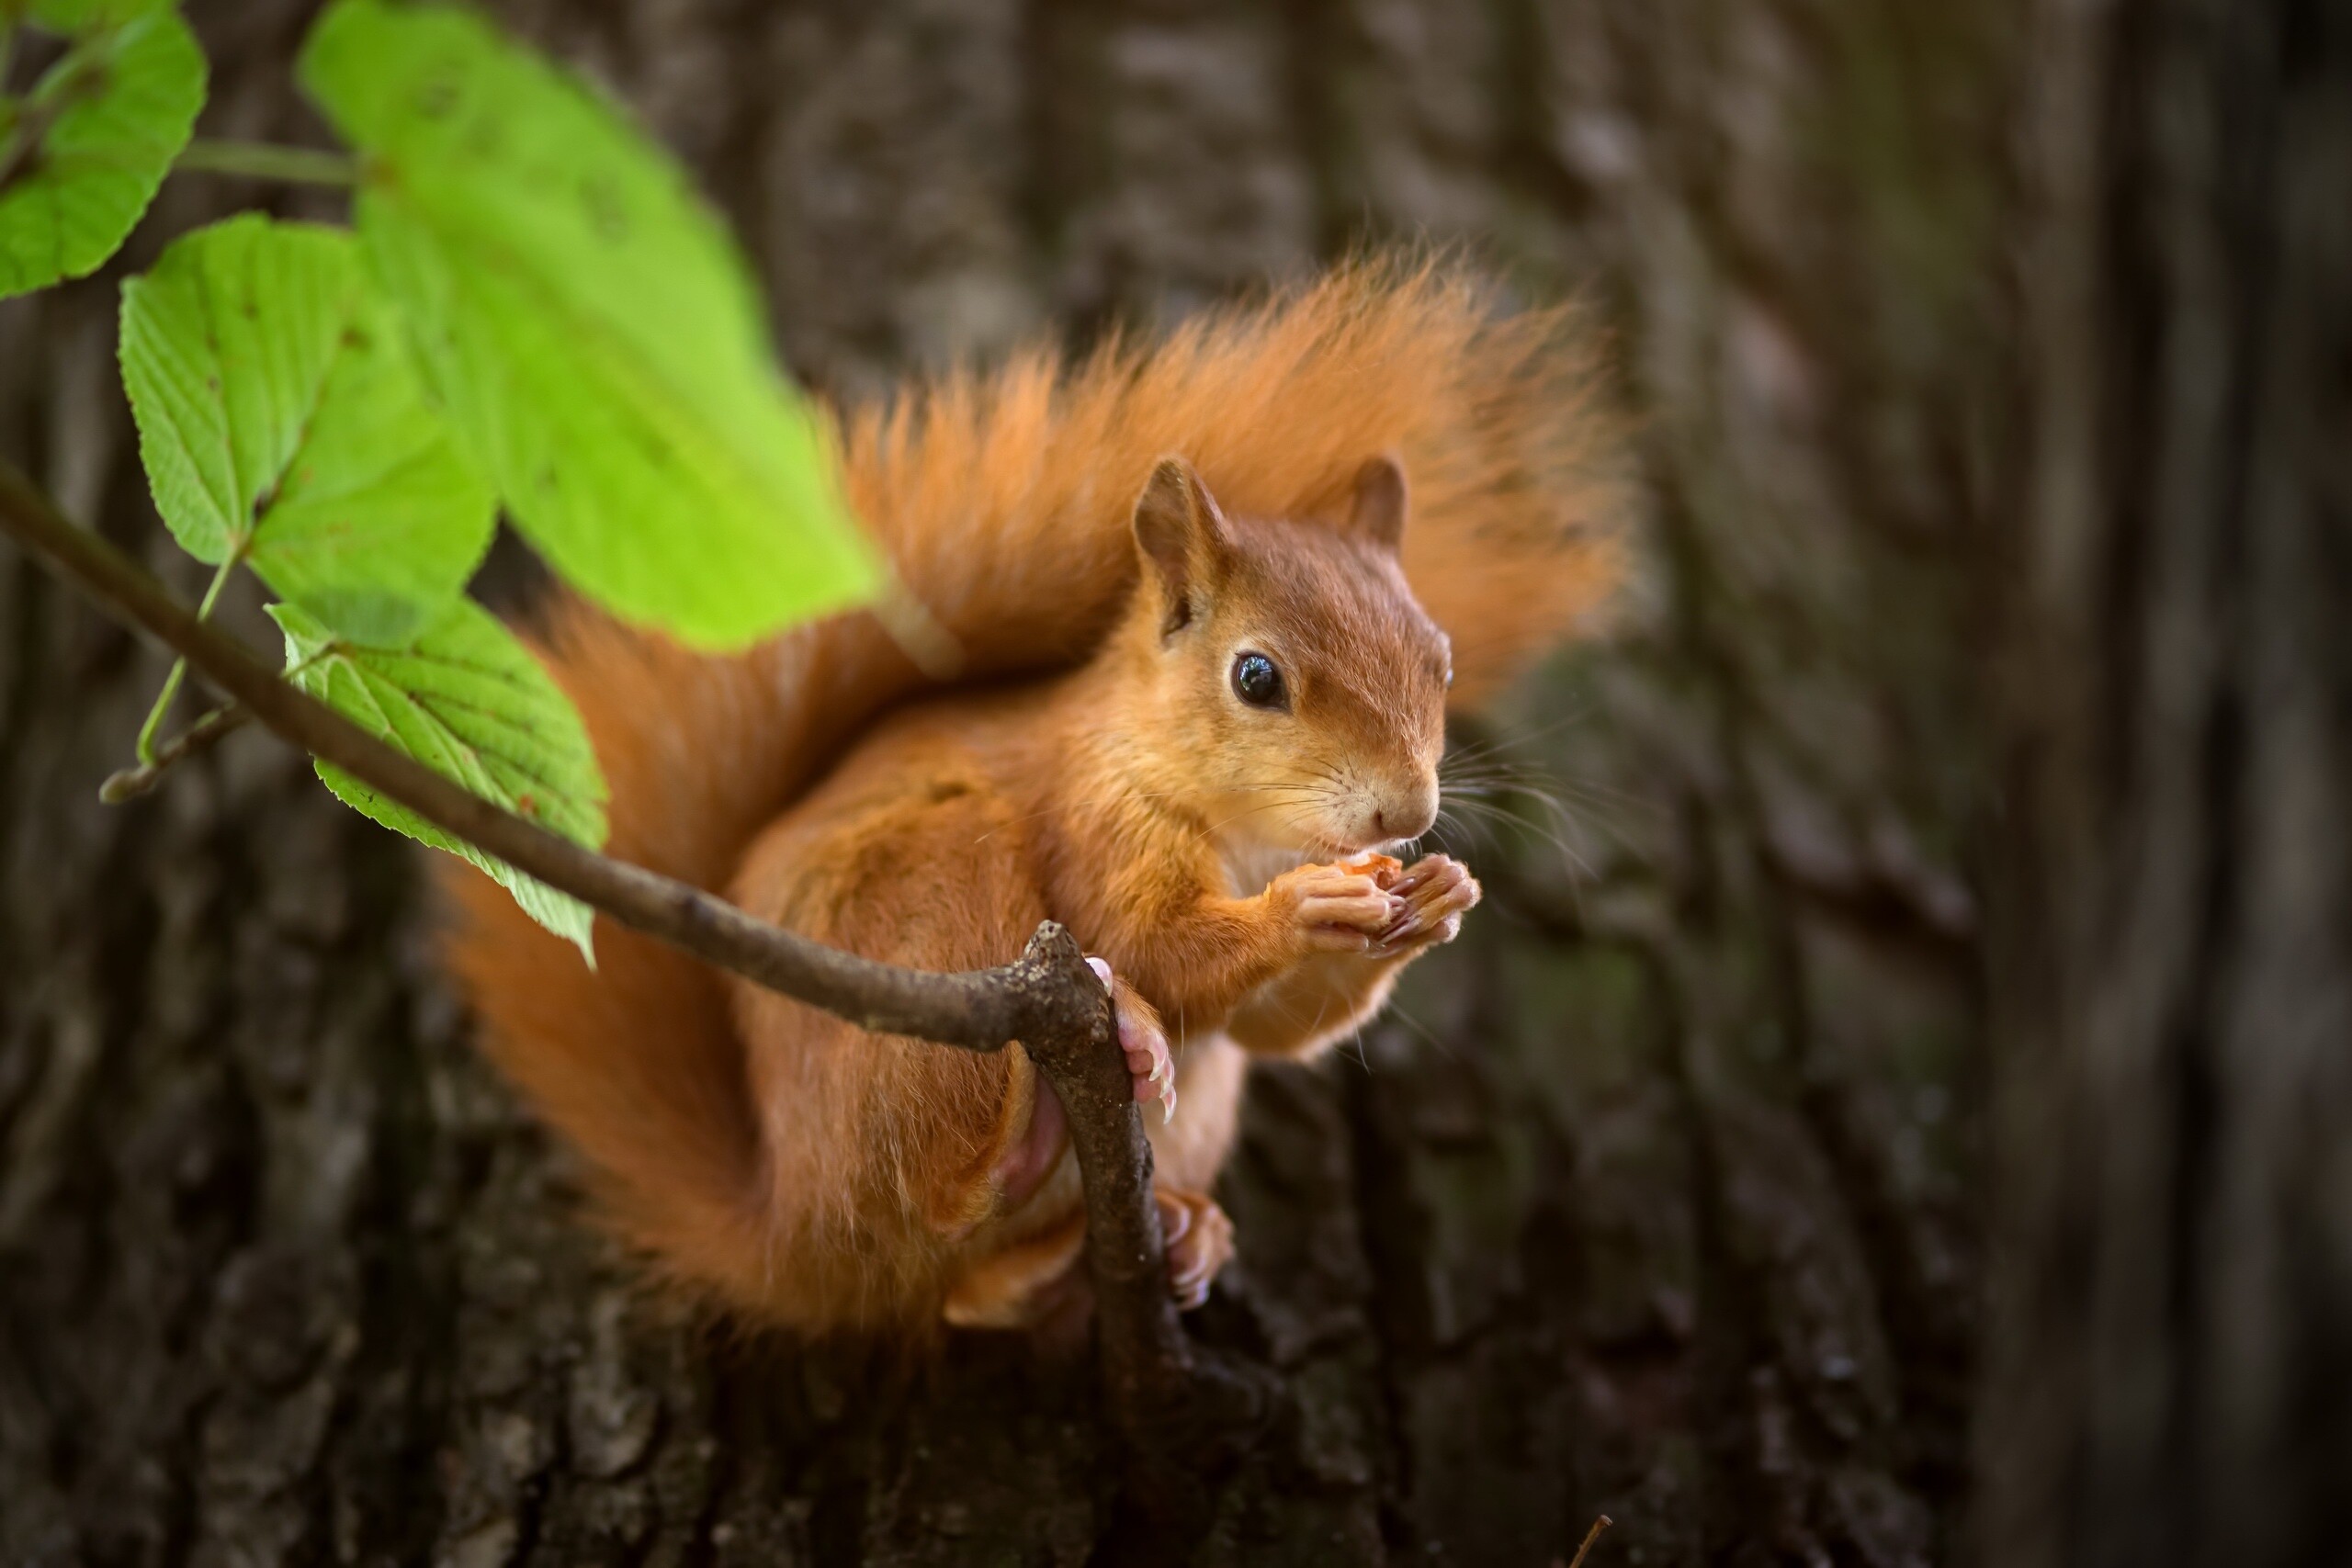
[0,461,1263,1509]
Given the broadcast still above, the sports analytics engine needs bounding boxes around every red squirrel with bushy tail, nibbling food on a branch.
[447,264,1625,1336]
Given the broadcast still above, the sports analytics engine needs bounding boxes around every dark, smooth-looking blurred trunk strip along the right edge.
[1985,0,2352,1568]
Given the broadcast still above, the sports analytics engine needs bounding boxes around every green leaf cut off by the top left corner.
[0,0,205,299]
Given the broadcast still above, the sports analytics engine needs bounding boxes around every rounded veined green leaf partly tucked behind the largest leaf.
[122,214,496,647]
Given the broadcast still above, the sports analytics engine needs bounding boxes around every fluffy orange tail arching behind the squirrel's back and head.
[433,261,1625,1309]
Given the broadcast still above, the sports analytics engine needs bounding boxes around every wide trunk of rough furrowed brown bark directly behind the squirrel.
[0,0,2016,1568]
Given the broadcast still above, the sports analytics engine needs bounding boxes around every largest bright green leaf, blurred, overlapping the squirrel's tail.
[299,0,879,647]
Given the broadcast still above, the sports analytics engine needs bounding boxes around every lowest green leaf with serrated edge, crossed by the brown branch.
[270,600,605,964]
